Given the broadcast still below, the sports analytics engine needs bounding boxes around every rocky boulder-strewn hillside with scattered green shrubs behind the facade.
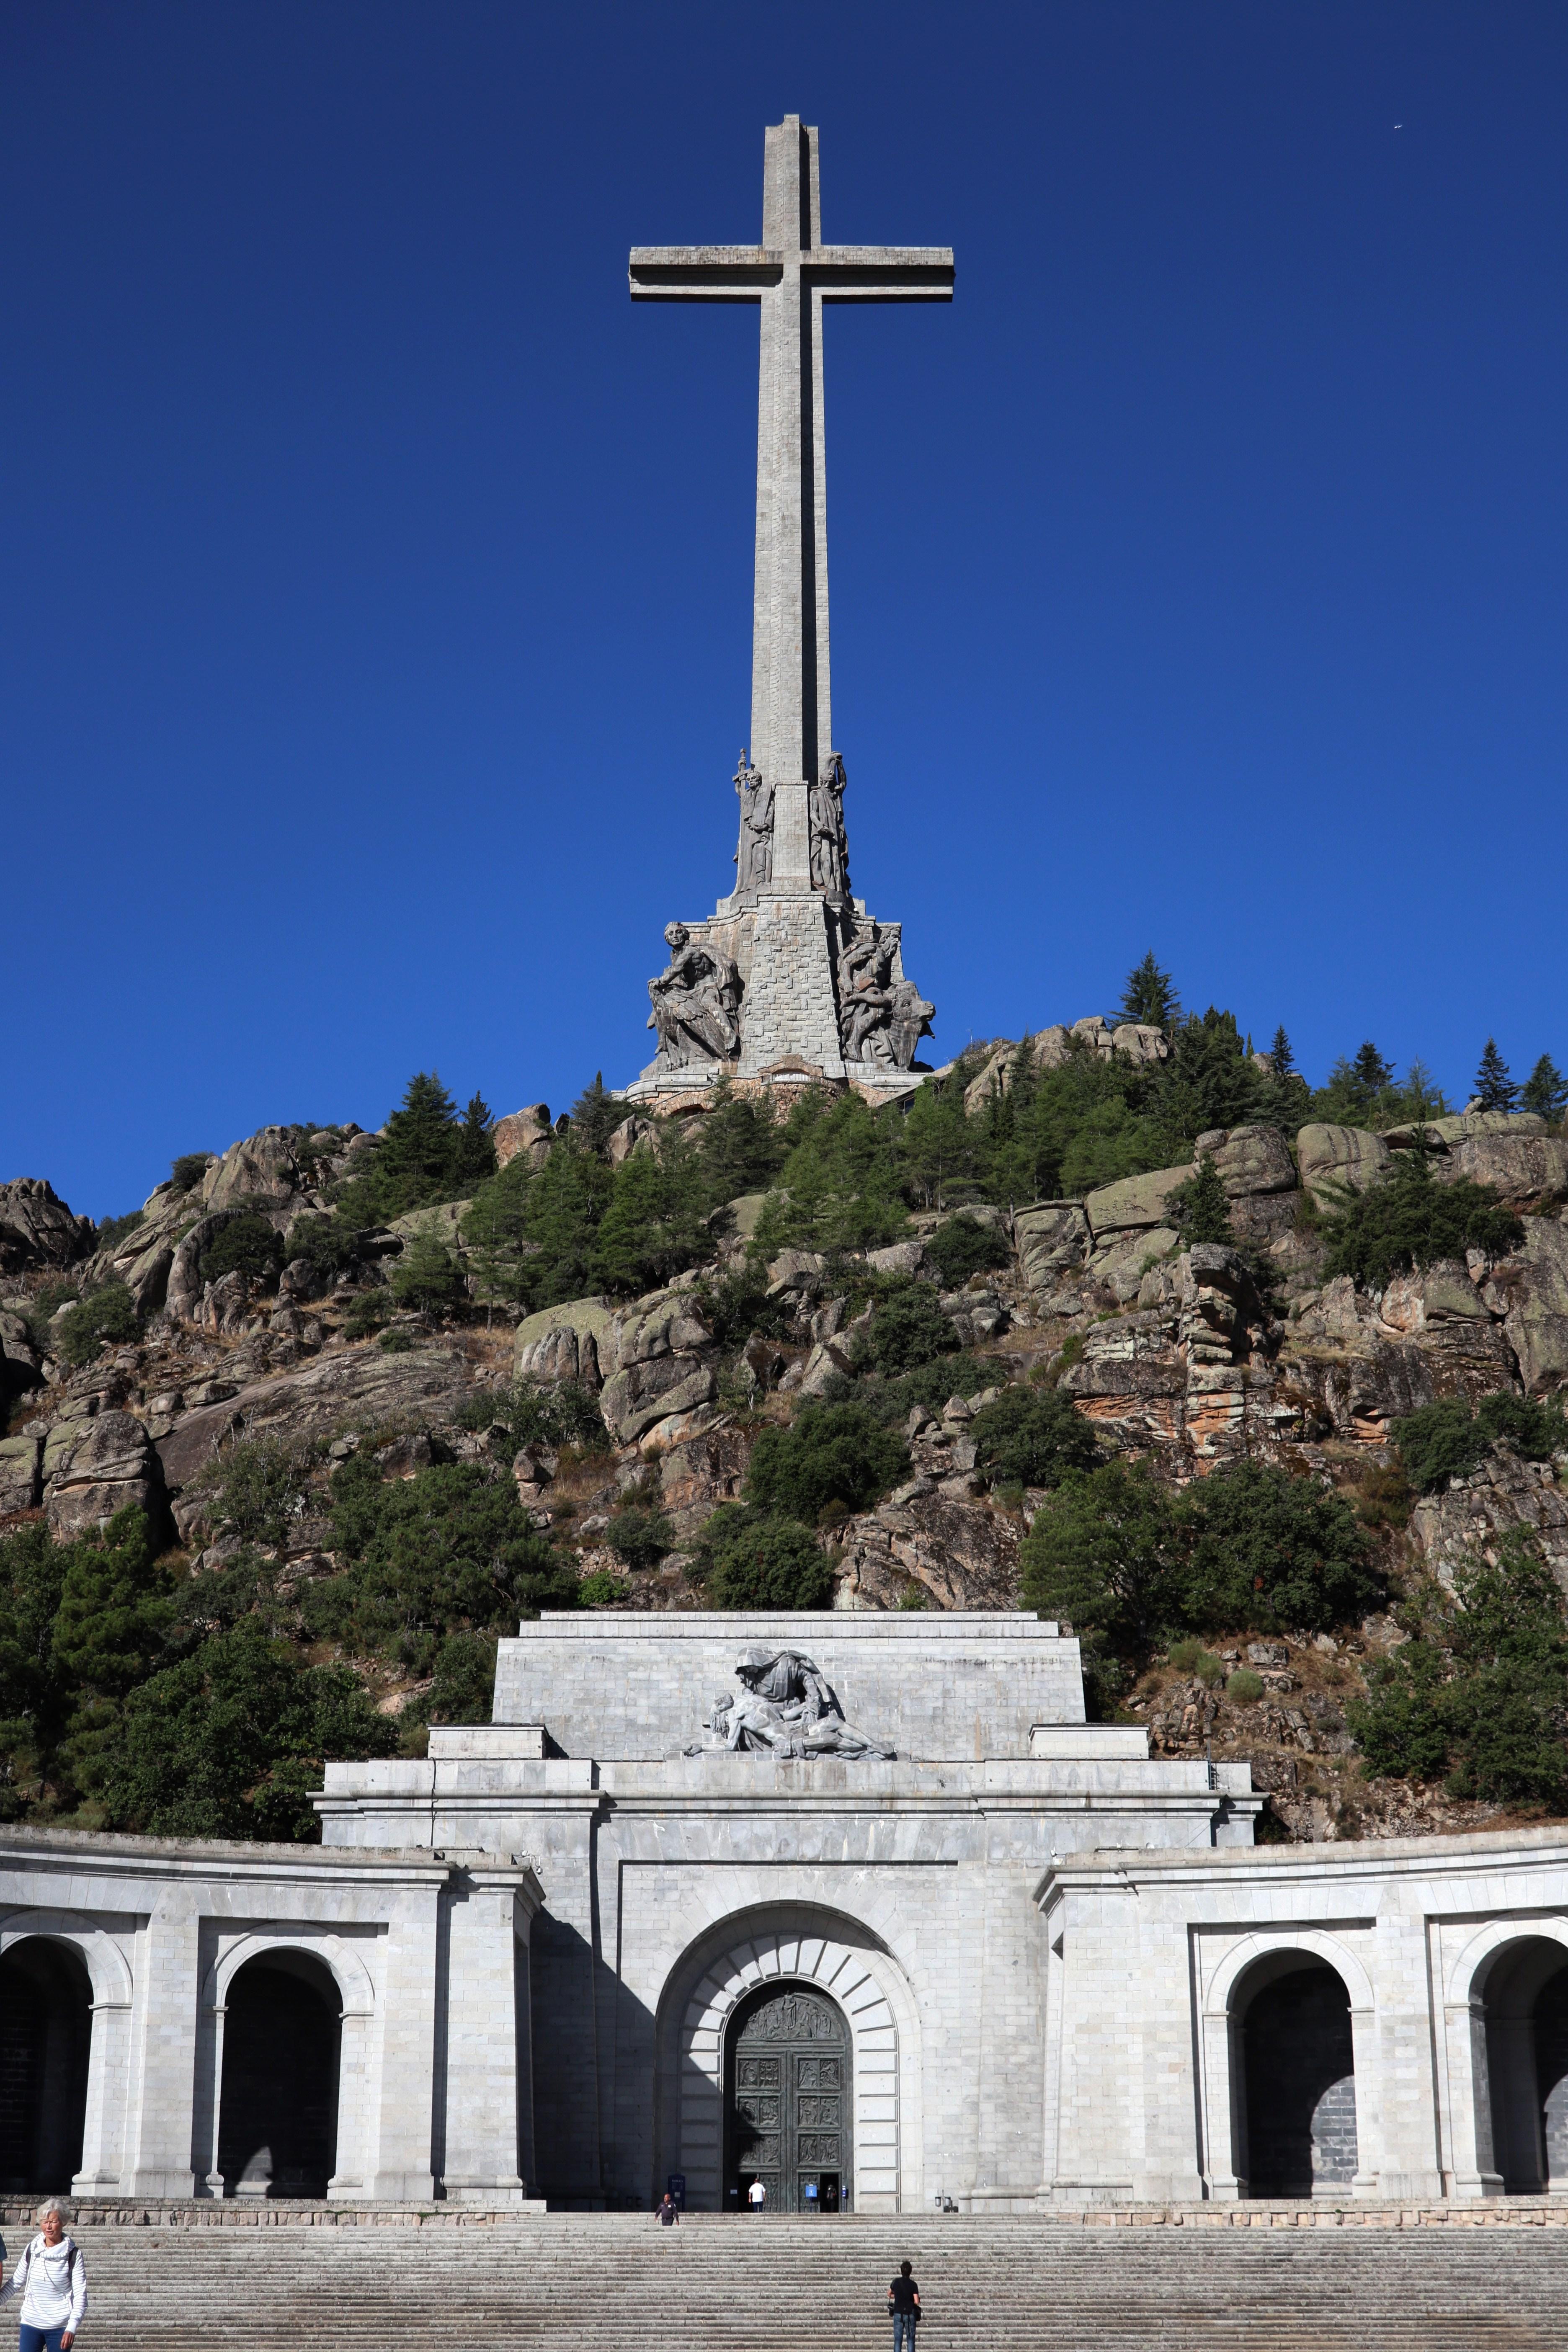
[0,1016,1568,1837]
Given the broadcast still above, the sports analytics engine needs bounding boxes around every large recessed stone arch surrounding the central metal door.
[656,1903,919,2213]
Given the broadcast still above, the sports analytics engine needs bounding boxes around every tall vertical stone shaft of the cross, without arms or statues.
[752,115,832,856]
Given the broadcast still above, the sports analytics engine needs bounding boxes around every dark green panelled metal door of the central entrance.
[724,1983,854,2213]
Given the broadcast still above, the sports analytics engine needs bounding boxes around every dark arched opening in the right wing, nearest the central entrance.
[1237,1952,1357,2197]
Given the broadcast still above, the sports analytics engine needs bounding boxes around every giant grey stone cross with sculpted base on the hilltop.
[628,133,952,1096]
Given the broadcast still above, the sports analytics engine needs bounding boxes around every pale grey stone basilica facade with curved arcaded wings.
[0,1611,1568,2211]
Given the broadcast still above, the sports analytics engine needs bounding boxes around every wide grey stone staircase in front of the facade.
[18,2204,1568,2352]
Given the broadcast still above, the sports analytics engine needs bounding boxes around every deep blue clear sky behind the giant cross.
[0,0,1568,1216]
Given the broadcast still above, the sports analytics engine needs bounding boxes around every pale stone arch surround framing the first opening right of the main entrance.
[1204,1926,1377,2197]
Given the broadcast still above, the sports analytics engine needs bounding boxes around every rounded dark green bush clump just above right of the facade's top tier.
[1023,1461,1382,1703]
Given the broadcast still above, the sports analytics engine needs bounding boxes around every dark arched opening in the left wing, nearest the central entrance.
[219,1952,343,2197]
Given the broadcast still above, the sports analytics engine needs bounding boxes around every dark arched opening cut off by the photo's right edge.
[1483,1936,1568,2197]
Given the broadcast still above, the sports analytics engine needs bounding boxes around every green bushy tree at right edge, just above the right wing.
[1345,1529,1568,1811]
